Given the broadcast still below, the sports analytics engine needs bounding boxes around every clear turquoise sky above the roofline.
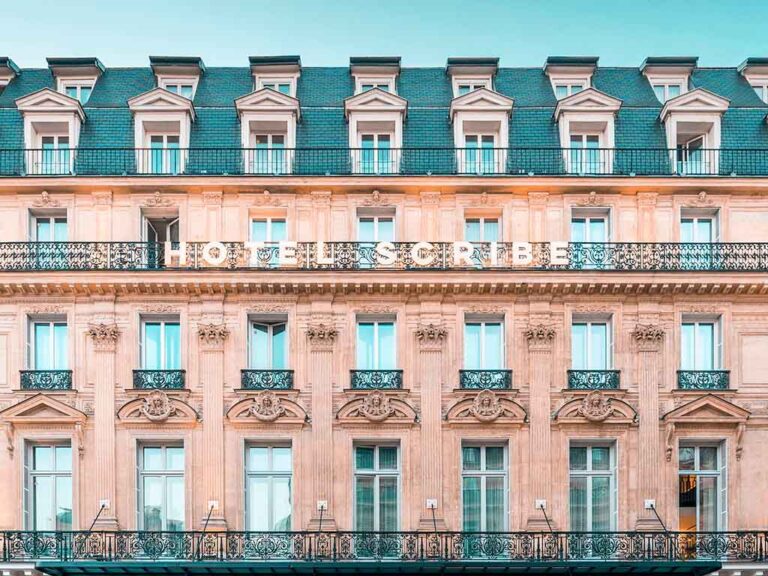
[6,0,768,67]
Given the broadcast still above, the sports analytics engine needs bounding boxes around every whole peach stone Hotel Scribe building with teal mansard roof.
[0,51,768,574]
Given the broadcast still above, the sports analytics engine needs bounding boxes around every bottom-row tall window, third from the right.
[461,446,507,532]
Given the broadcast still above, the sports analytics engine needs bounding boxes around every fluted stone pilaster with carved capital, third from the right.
[416,323,448,530]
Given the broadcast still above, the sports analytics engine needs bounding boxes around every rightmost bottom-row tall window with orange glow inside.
[678,445,728,532]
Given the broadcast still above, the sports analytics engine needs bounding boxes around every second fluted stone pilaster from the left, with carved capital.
[197,323,229,530]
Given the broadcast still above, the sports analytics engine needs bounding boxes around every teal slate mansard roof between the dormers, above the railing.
[0,66,768,148]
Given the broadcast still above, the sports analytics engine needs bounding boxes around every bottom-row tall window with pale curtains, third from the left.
[245,446,292,532]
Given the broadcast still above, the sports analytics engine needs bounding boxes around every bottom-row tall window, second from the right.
[568,445,617,532]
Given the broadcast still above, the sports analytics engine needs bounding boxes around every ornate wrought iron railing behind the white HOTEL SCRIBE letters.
[0,242,768,272]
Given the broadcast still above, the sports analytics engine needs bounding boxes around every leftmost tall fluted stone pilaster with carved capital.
[86,323,120,530]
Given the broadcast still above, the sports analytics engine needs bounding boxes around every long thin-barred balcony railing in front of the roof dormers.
[0,148,768,177]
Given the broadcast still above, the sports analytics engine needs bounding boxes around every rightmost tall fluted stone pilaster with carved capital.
[632,324,664,530]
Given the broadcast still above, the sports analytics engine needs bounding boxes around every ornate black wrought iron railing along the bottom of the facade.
[0,531,768,564]
